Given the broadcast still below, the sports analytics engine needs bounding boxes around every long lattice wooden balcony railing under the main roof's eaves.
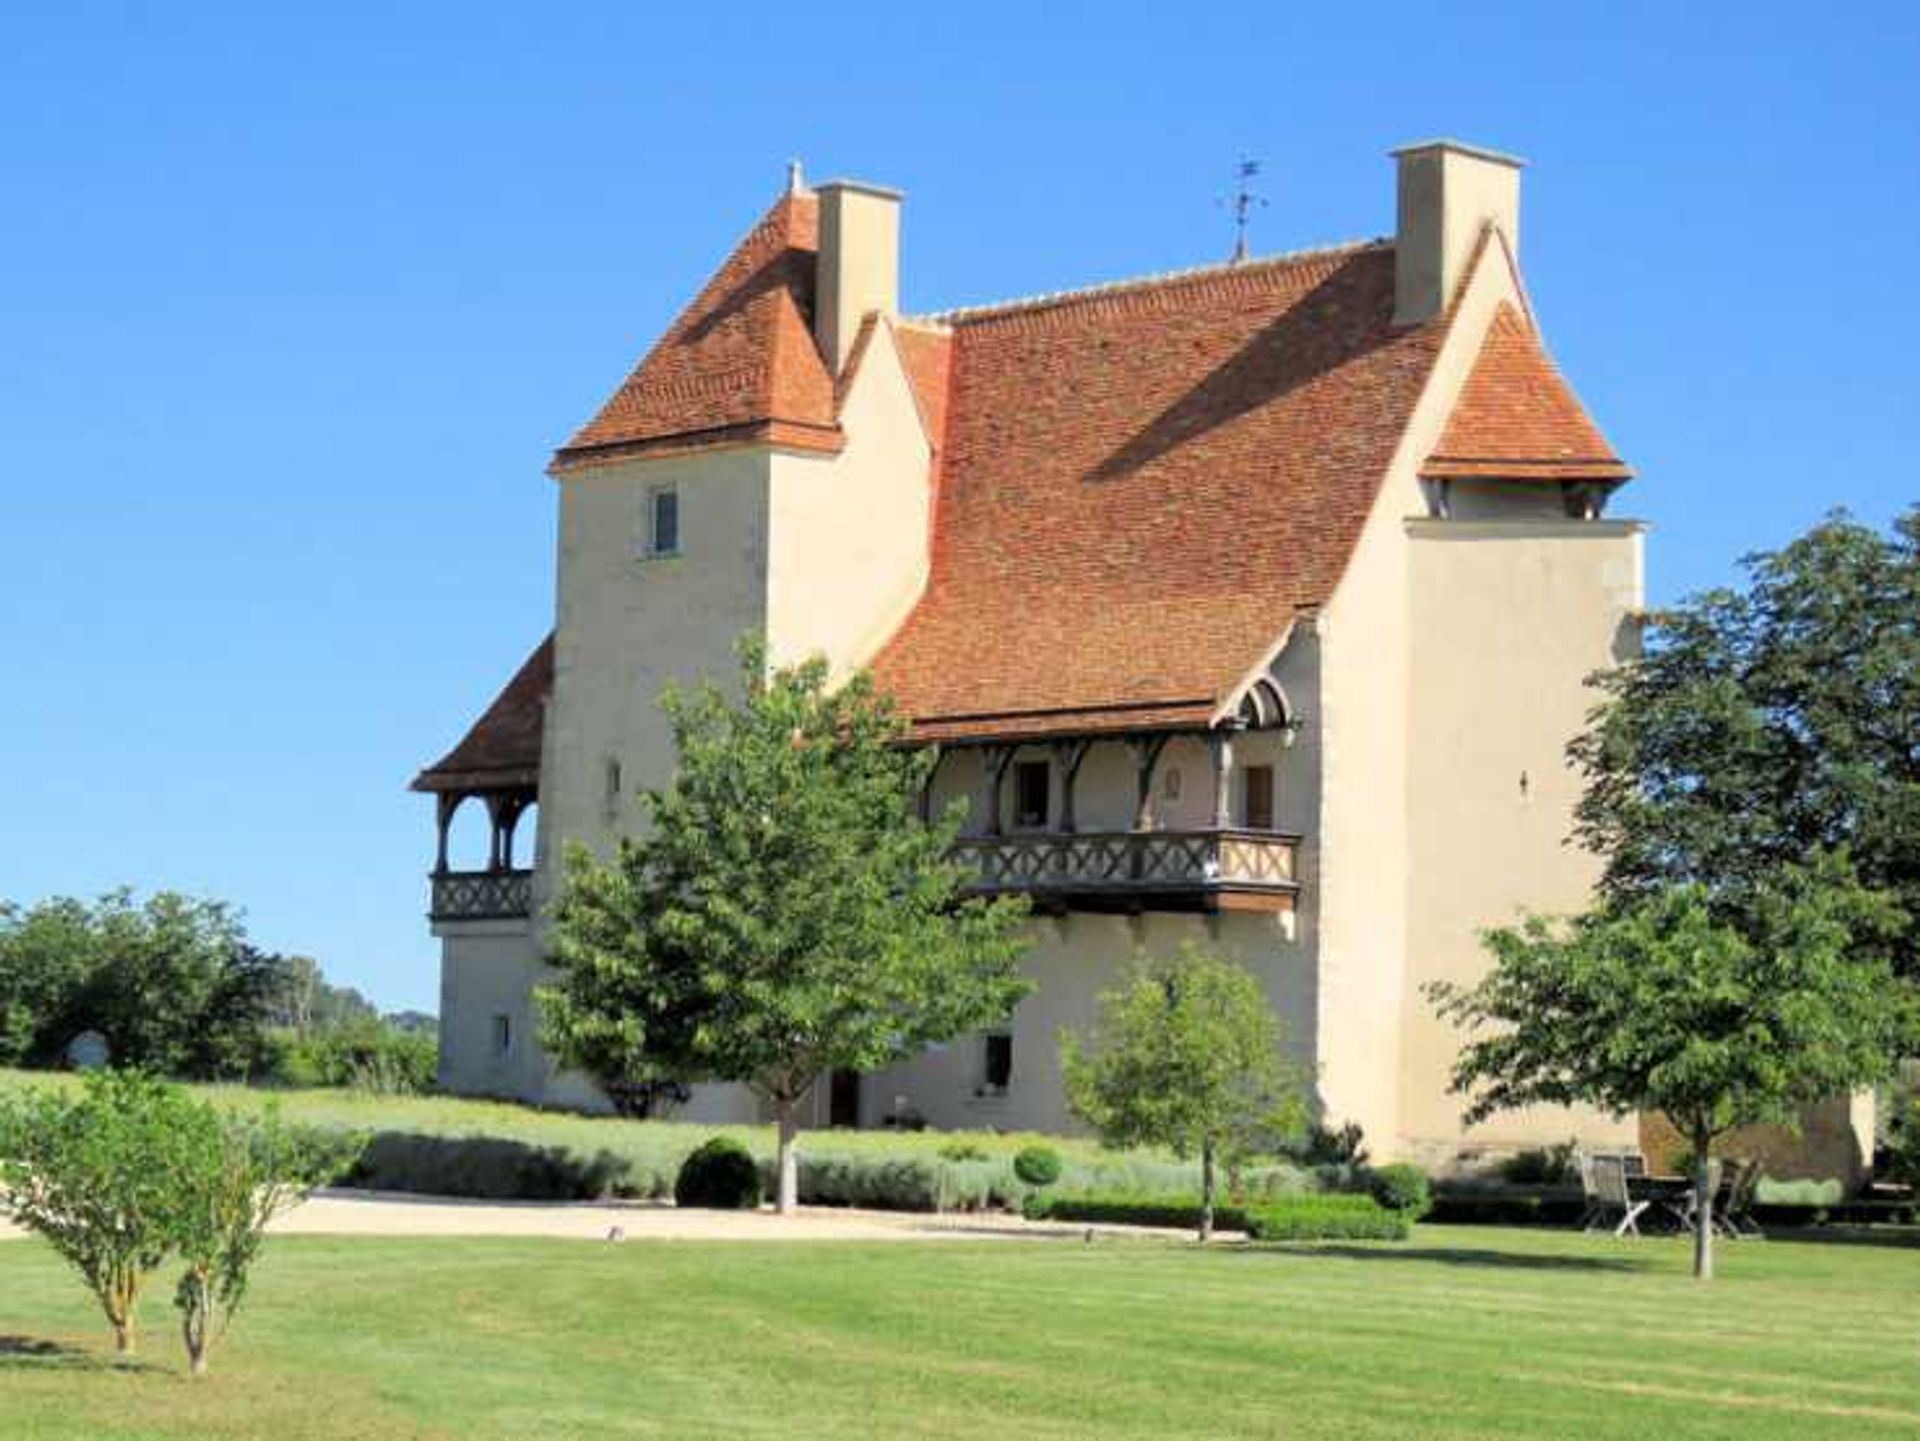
[954,829,1300,911]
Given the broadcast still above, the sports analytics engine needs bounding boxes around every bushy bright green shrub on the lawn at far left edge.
[0,1071,200,1355]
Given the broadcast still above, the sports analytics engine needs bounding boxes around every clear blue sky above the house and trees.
[0,2,1920,1007]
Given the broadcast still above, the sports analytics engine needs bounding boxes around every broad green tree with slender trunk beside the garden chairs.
[1428,854,1920,1278]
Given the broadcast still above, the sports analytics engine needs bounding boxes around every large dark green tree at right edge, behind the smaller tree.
[1572,507,1920,979]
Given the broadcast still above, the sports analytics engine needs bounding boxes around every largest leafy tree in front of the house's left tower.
[541,641,1027,1211]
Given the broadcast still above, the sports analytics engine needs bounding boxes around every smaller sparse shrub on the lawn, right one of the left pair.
[167,1103,361,1376]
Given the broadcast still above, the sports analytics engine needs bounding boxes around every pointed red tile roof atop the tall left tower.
[553,194,841,470]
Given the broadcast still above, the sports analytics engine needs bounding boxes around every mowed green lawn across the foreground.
[0,1226,1920,1441]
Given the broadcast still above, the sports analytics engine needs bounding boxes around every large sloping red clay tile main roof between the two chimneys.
[874,244,1444,739]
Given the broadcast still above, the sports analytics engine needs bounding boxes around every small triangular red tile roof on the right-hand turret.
[1421,305,1634,480]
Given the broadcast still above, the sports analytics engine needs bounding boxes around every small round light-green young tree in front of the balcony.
[1060,944,1306,1241]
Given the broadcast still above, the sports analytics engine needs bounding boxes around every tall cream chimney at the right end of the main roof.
[1390,140,1526,324]
